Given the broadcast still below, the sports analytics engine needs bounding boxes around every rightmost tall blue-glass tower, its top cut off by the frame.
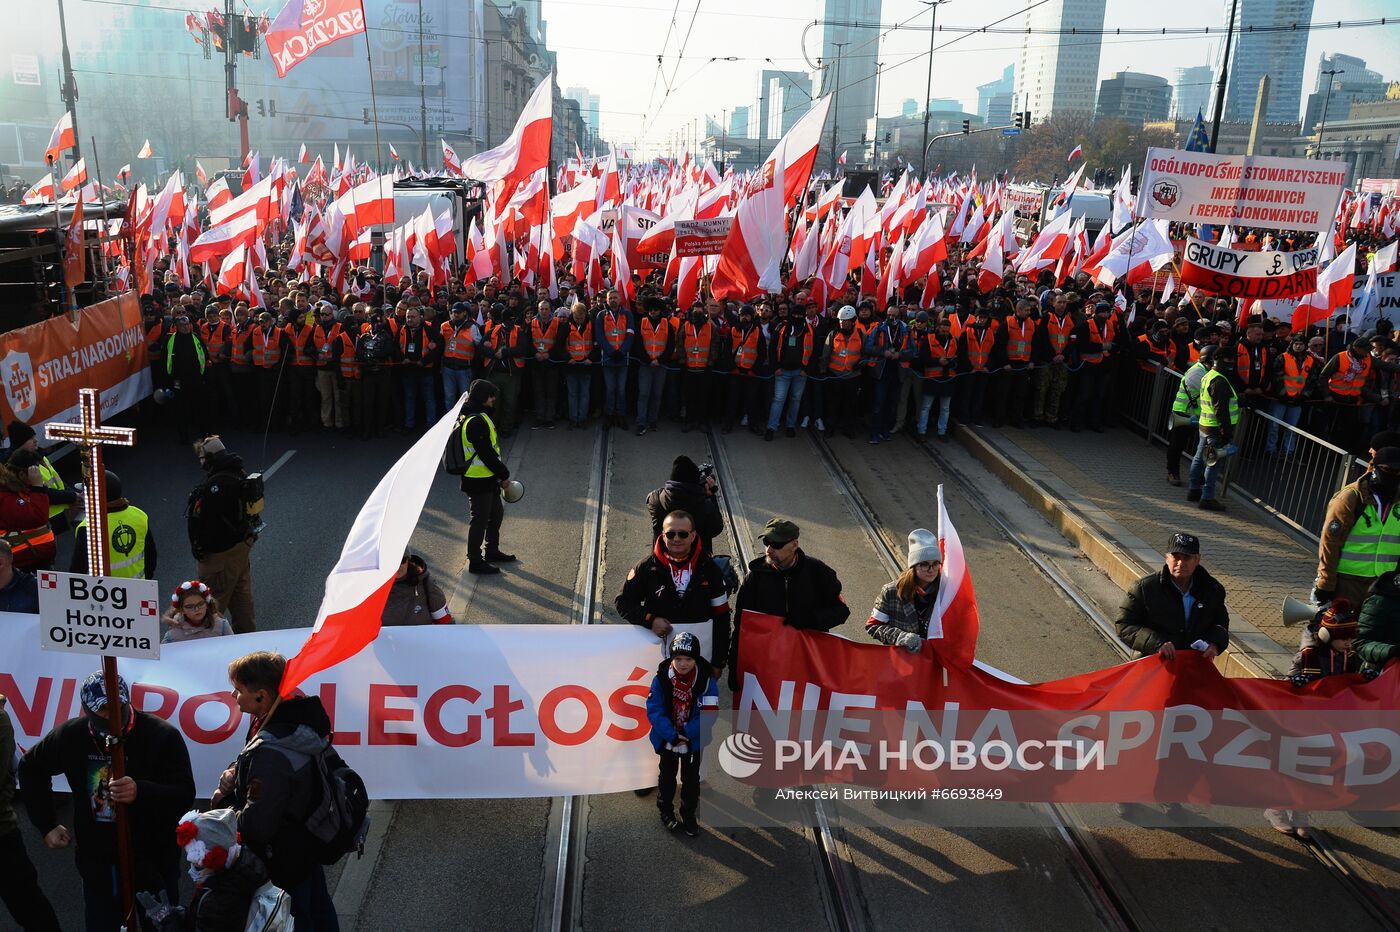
[1225,0,1313,123]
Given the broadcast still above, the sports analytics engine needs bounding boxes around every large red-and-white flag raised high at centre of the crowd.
[710,97,832,299]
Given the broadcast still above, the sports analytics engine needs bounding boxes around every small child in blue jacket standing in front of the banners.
[647,631,720,838]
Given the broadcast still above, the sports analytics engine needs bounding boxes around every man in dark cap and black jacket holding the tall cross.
[18,673,195,932]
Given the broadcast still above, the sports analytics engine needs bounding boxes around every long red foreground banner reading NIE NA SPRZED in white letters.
[718,613,1400,810]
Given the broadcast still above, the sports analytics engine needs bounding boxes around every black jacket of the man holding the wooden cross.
[18,712,195,873]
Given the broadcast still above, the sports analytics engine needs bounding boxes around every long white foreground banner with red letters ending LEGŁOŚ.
[0,613,710,799]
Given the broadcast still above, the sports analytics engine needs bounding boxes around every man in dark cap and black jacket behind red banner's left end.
[729,516,851,690]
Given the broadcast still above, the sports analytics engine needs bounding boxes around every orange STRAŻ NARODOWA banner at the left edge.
[0,291,151,437]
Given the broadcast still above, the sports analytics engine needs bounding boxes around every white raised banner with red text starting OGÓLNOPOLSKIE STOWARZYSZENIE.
[1135,148,1351,231]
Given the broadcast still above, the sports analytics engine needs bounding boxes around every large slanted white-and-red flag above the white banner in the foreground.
[280,399,459,697]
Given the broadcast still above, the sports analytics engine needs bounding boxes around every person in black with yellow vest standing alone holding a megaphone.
[461,379,515,575]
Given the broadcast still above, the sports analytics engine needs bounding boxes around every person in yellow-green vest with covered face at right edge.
[1312,446,1400,605]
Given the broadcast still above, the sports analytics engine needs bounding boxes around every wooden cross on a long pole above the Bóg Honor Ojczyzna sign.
[43,389,139,929]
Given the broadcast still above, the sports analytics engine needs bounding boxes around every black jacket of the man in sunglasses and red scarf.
[613,540,729,668]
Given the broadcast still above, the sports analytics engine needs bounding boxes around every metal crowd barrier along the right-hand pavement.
[1119,364,1366,540]
